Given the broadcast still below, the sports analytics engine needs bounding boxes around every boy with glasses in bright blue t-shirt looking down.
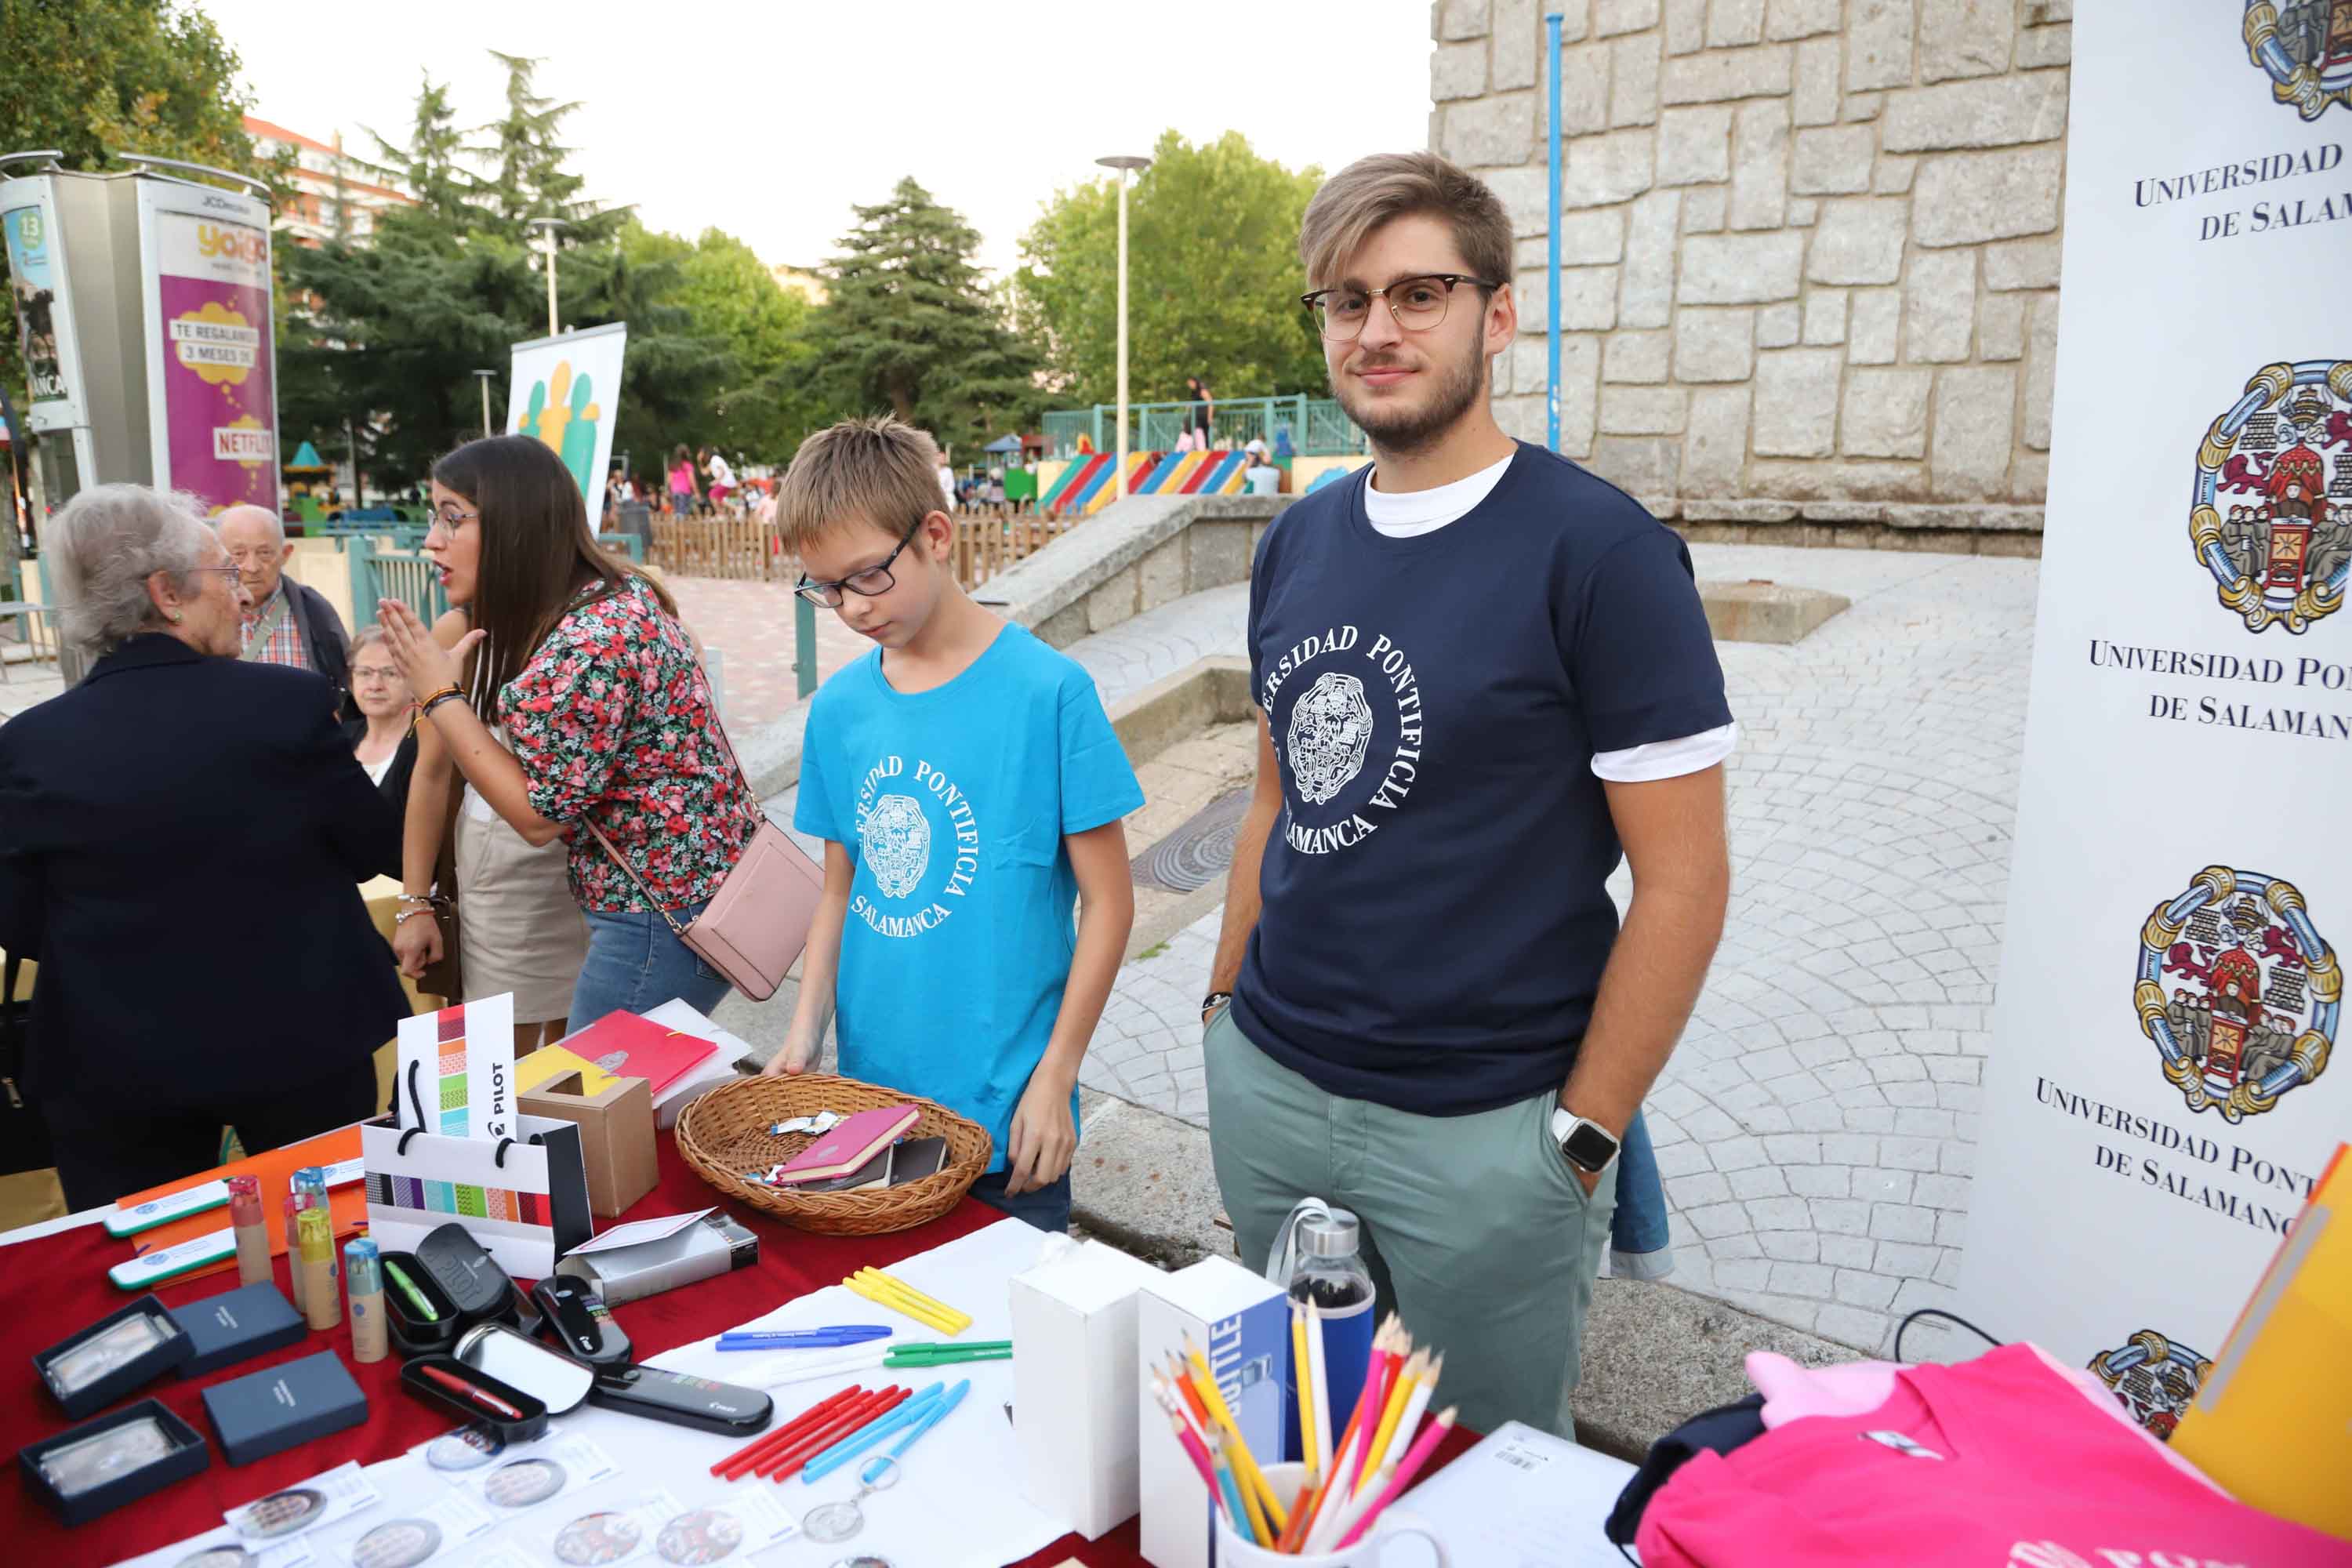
[767,419,1143,1229]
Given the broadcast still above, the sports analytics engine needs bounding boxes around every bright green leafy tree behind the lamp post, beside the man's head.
[1011,132,1324,402]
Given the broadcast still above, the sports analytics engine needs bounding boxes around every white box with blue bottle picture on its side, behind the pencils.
[1134,1258,1291,1568]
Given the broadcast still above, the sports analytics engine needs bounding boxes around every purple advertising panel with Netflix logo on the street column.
[139,179,278,513]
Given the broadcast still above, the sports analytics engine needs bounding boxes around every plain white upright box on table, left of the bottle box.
[1011,1241,1160,1540]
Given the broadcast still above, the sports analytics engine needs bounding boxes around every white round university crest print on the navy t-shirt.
[1258,626,1421,855]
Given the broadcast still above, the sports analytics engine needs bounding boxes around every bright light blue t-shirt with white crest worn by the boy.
[793,626,1143,1171]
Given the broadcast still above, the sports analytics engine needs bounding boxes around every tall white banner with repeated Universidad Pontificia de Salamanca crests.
[1952,0,2352,1434]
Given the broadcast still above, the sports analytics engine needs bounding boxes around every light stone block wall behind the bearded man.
[1430,0,2072,553]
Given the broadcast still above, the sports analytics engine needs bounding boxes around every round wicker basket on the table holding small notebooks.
[677,1072,990,1236]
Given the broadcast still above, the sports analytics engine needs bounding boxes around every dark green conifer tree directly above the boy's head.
[811,176,1042,460]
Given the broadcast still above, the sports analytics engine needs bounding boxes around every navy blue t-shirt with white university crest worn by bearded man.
[1232,445,1731,1116]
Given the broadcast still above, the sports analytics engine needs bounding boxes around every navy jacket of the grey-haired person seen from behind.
[0,635,409,1107]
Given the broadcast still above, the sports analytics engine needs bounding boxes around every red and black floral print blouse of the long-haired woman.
[499,576,753,912]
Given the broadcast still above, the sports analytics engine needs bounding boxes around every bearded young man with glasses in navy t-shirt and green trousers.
[1202,153,1733,1434]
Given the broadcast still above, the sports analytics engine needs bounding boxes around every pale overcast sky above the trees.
[198,0,1430,278]
